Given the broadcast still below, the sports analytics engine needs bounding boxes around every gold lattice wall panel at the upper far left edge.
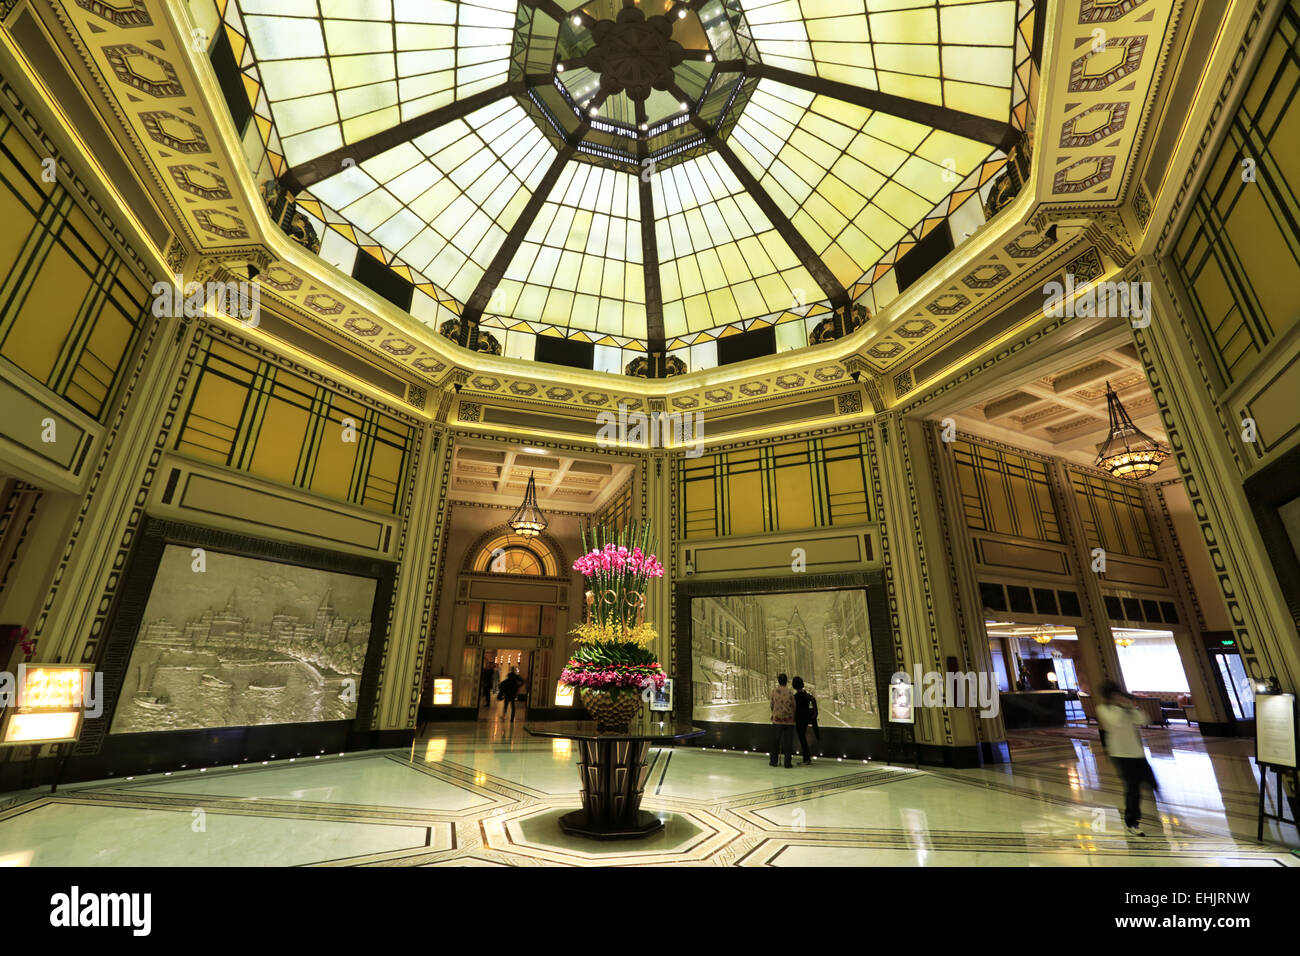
[0,114,150,419]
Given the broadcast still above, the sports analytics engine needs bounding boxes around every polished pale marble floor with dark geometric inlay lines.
[0,721,1300,866]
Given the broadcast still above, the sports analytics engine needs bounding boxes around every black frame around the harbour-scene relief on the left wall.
[61,516,397,780]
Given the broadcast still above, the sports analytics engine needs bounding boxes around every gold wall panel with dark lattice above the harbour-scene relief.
[176,338,411,514]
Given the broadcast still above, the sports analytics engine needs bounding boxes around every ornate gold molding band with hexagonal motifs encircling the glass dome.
[10,0,1227,411]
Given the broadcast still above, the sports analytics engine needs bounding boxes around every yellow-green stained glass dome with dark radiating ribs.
[225,0,1032,371]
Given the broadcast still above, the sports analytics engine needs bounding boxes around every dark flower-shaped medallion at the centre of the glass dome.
[582,0,685,101]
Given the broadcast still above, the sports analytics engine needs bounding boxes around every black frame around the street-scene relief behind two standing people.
[673,571,900,760]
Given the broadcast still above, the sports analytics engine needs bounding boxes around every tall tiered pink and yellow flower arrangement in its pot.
[560,522,666,730]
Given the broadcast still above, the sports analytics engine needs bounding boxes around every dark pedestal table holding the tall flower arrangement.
[524,721,705,840]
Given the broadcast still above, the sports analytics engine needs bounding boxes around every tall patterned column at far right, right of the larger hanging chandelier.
[1131,256,1300,691]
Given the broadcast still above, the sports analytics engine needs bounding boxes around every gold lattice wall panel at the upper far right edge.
[1173,0,1300,384]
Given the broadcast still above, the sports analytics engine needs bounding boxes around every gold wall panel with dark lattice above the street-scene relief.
[677,432,871,538]
